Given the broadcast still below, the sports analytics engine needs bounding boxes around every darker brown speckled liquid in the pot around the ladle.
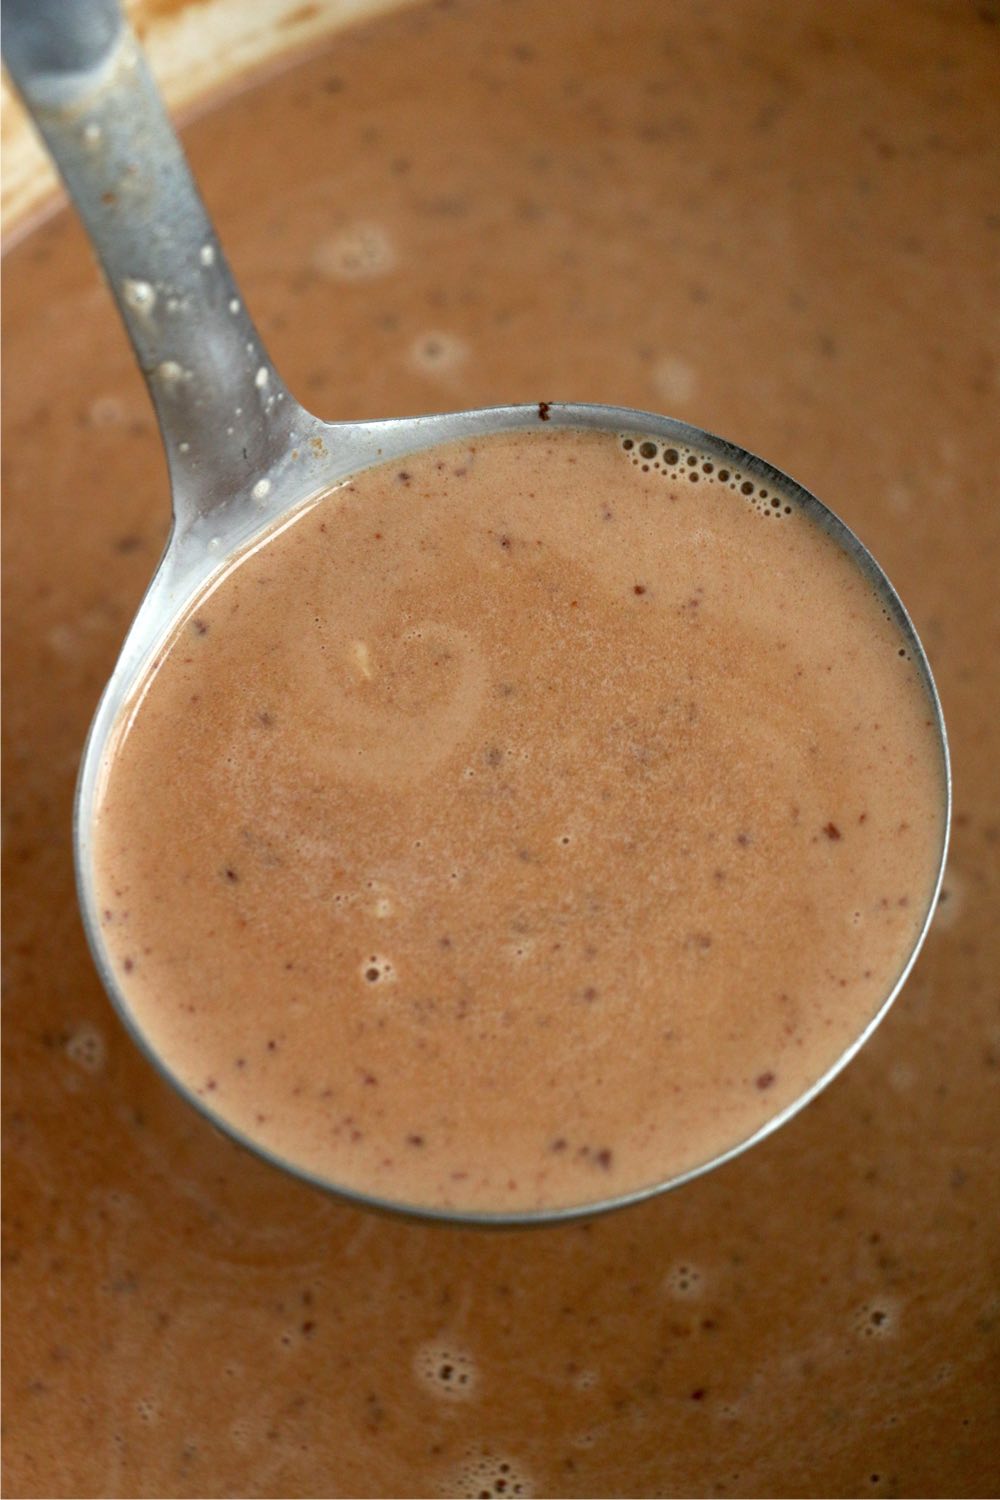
[4,0,1000,1496]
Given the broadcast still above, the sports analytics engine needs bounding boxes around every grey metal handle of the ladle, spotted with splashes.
[1,0,310,522]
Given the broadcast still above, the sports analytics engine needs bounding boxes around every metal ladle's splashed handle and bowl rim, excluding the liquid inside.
[3,0,951,1224]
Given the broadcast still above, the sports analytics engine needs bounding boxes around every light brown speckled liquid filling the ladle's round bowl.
[96,431,943,1211]
